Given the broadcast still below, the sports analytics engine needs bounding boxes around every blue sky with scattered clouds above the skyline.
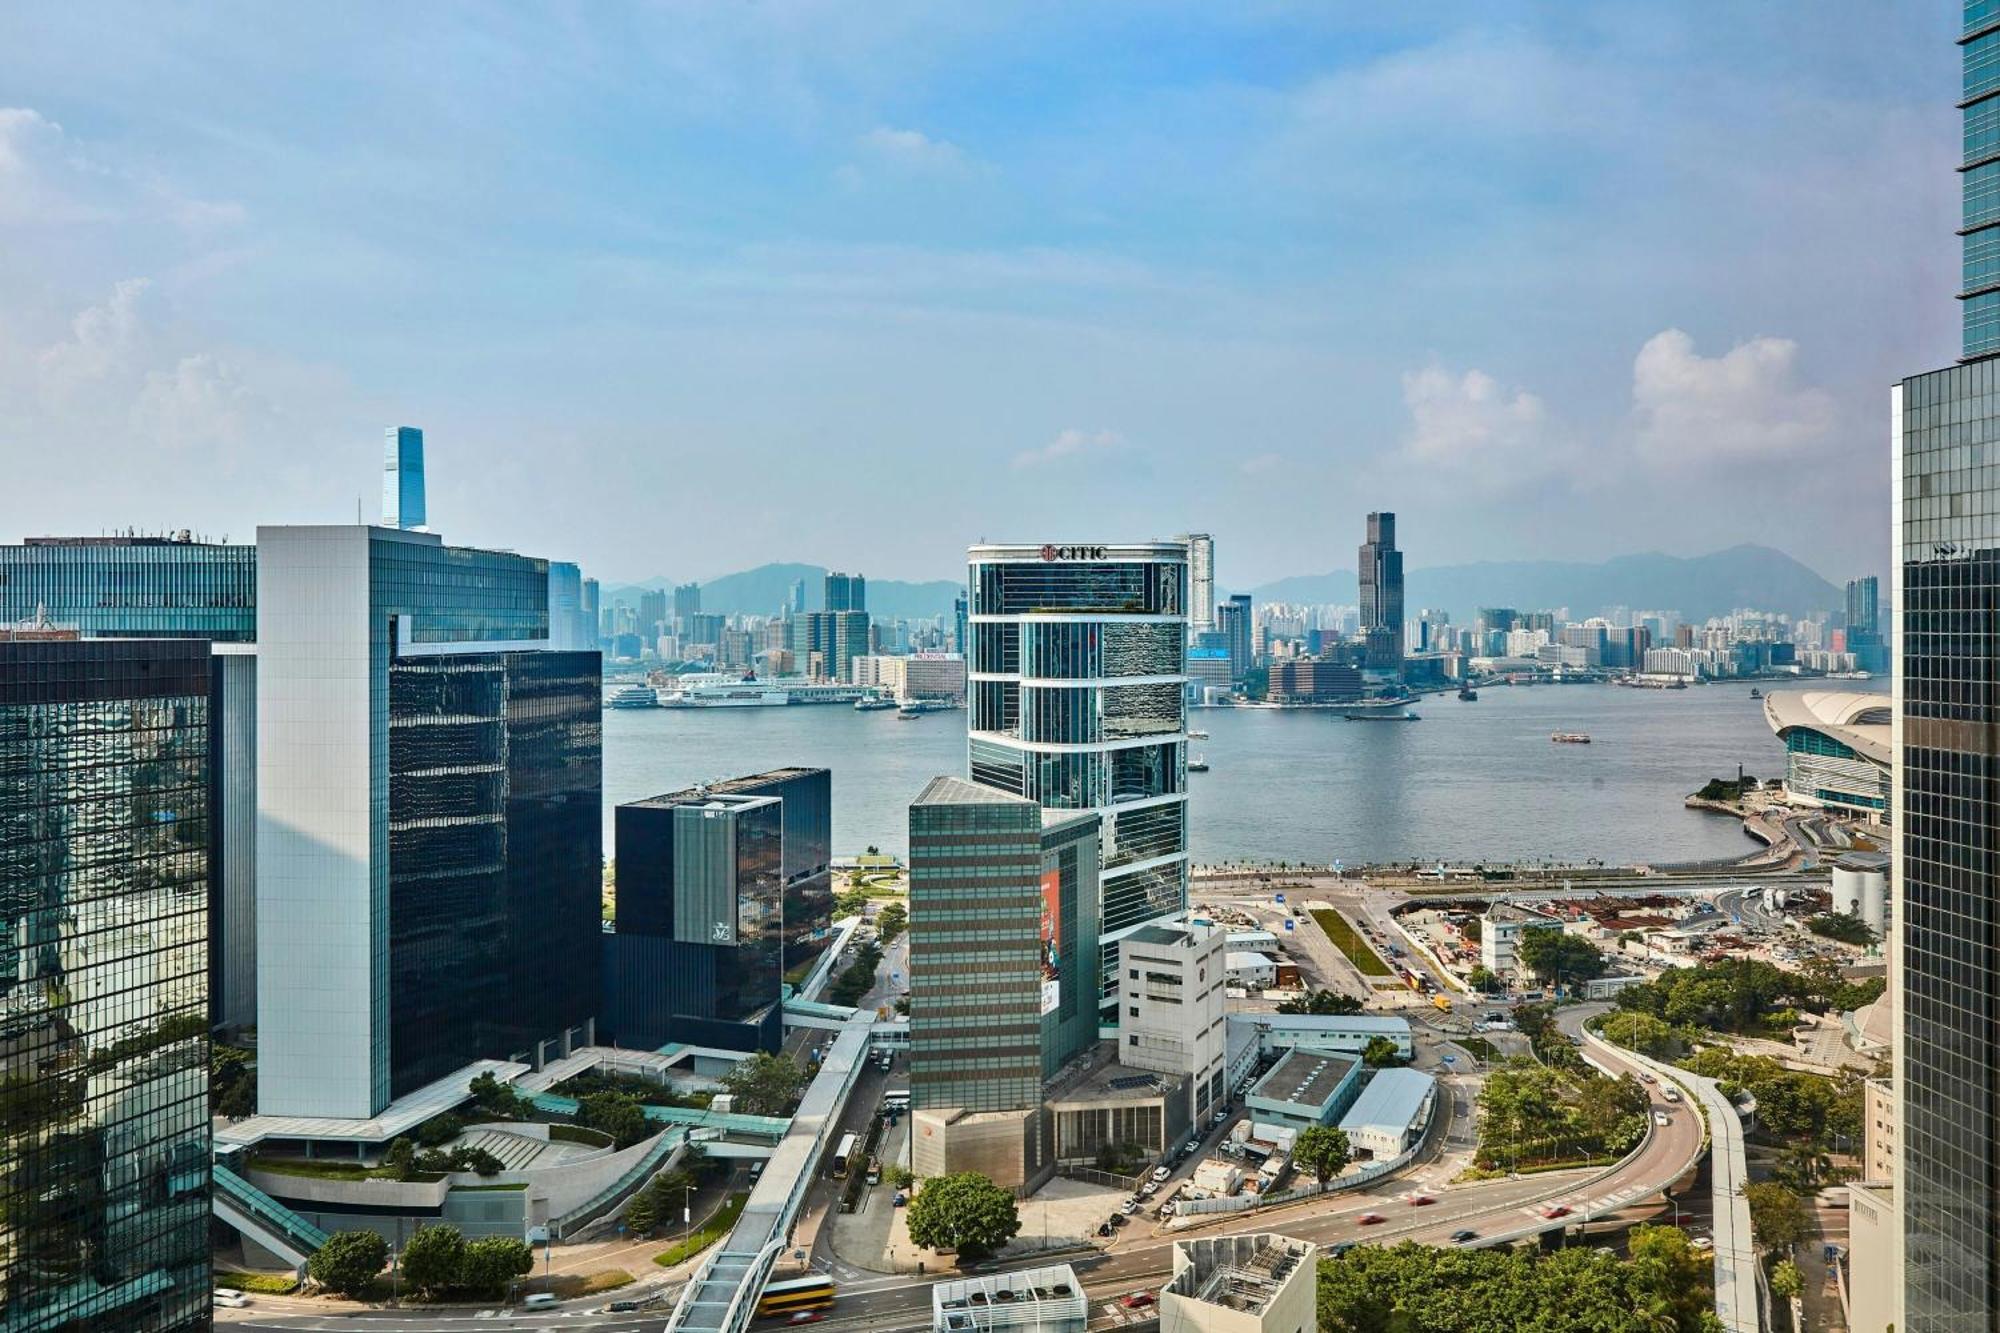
[0,0,1958,586]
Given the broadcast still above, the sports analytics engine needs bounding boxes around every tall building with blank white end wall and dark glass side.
[256,526,602,1119]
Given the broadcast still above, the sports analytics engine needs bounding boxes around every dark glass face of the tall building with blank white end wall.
[388,652,604,1099]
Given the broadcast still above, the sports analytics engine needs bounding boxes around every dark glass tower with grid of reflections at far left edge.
[0,638,210,1333]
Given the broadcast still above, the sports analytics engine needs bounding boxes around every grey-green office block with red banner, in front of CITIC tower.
[910,777,1116,1189]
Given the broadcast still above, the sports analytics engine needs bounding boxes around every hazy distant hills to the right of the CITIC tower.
[1250,544,1846,622]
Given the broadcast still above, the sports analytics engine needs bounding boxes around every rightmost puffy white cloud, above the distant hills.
[1632,328,1838,470]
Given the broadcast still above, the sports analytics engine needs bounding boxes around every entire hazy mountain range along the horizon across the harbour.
[604,544,1846,622]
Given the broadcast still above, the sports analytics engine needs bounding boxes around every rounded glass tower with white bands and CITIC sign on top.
[966,542,1188,1008]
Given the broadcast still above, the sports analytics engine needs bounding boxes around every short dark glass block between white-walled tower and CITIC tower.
[600,769,796,1051]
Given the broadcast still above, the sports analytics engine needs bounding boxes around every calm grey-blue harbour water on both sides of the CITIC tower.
[604,683,1868,863]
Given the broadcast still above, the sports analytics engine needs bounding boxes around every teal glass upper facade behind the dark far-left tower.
[0,536,256,642]
